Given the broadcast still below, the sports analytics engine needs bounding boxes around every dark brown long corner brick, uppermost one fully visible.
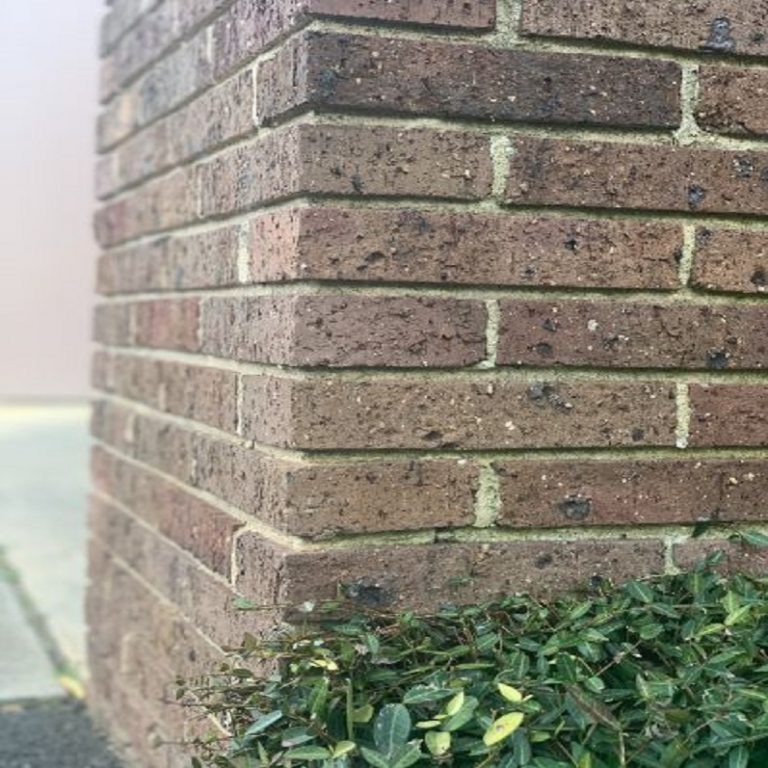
[257,32,681,128]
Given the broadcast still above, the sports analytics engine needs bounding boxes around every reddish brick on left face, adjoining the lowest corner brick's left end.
[91,447,242,577]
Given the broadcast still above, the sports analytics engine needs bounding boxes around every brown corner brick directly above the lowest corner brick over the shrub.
[193,435,478,539]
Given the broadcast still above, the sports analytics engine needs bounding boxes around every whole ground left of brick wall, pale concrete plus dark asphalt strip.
[0,404,121,768]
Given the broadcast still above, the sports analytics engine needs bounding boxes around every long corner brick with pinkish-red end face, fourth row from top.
[251,207,682,290]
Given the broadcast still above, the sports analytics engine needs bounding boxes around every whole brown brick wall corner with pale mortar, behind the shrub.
[88,0,768,768]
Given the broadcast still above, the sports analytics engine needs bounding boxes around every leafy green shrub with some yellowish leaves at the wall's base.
[182,556,768,768]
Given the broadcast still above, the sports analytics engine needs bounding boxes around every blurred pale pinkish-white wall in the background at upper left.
[0,0,103,399]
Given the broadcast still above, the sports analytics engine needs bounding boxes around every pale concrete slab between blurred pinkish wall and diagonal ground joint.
[0,403,88,674]
